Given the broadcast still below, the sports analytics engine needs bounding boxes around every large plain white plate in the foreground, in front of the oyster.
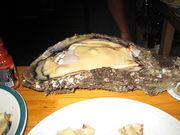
[28,98,180,135]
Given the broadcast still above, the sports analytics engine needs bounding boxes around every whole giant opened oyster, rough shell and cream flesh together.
[22,34,180,96]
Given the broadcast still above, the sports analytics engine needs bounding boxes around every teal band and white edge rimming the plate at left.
[0,85,27,135]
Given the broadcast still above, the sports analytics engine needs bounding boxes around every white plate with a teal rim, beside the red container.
[0,85,27,135]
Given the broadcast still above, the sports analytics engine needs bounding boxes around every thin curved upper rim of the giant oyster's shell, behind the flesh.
[23,33,134,85]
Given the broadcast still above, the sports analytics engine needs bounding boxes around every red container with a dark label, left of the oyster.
[0,41,19,88]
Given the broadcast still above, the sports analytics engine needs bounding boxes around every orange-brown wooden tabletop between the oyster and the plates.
[16,66,180,135]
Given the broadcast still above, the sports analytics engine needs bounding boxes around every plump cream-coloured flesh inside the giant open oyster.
[43,40,138,78]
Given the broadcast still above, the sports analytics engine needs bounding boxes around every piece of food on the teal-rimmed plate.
[0,113,11,135]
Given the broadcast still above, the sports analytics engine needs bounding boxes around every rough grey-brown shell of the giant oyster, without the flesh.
[22,34,180,96]
